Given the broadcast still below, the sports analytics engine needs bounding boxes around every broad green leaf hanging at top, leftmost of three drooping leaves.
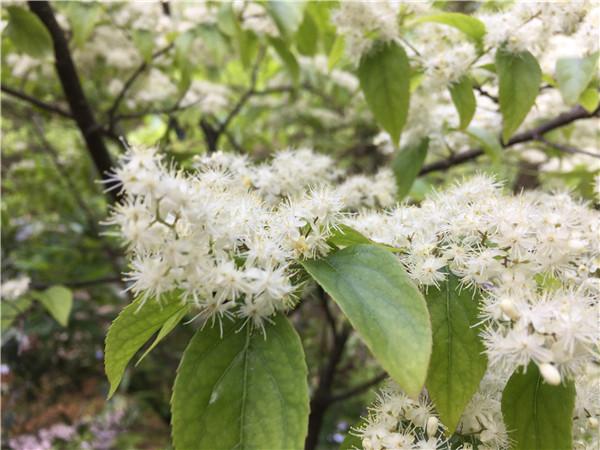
[358,42,410,144]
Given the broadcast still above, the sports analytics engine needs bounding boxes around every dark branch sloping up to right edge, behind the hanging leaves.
[419,106,600,176]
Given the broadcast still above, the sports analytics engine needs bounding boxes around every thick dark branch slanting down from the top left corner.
[28,1,118,200]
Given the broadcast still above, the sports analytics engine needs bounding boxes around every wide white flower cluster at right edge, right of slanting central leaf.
[348,176,600,383]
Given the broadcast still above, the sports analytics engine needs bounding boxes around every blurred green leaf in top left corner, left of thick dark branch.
[6,6,52,58]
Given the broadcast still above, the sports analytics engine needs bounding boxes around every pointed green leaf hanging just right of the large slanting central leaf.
[425,274,487,435]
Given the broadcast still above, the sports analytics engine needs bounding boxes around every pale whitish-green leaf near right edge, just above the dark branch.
[555,52,599,105]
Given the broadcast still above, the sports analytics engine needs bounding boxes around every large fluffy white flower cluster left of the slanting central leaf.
[107,149,395,327]
